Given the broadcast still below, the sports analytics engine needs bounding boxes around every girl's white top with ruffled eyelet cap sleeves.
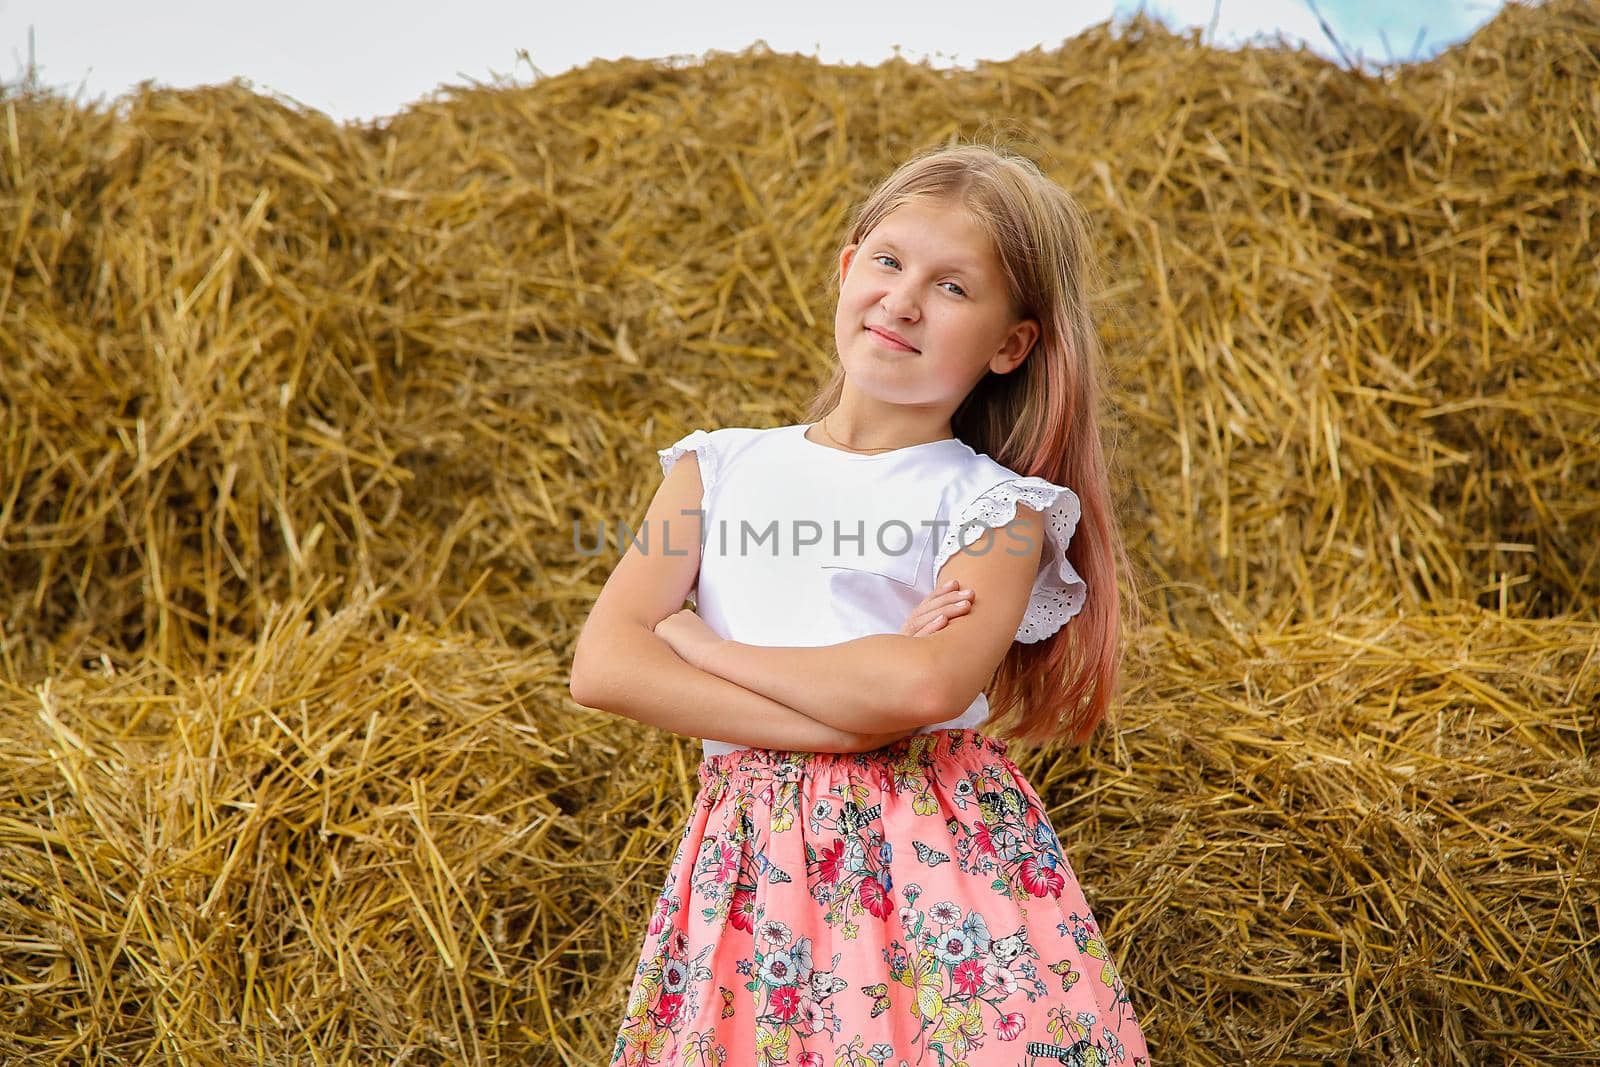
[658,424,1088,755]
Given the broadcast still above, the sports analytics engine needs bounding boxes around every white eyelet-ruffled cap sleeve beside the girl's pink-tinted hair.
[933,477,1088,645]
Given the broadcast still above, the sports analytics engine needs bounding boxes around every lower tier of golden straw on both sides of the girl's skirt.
[0,601,1600,1064]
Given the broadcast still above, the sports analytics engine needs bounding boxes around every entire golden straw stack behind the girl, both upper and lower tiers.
[0,2,1600,1064]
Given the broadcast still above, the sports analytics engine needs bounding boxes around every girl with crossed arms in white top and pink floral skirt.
[571,146,1149,1067]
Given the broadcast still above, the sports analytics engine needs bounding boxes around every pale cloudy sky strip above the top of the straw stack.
[0,0,1499,120]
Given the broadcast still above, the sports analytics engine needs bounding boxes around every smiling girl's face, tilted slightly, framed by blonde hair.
[834,202,1038,416]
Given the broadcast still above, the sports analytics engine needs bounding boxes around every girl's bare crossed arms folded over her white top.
[571,456,1043,752]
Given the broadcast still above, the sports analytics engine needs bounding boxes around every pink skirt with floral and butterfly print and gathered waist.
[611,729,1150,1067]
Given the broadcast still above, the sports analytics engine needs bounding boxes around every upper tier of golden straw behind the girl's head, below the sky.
[0,3,1600,665]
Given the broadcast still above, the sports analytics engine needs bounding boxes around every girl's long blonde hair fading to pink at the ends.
[806,137,1139,744]
